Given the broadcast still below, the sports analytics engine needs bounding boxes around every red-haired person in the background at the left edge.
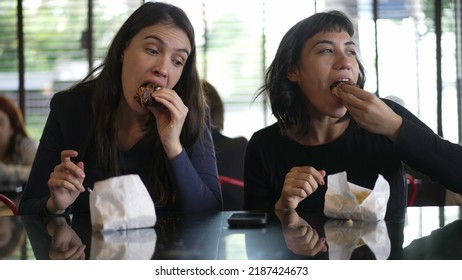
[0,96,37,185]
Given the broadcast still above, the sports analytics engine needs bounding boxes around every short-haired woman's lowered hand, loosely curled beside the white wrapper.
[275,166,326,210]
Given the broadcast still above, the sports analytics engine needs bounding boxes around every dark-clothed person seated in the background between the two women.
[202,80,247,210]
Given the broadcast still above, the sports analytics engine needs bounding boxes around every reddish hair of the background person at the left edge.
[0,96,27,160]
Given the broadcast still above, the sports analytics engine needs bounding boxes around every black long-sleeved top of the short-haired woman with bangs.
[244,100,462,217]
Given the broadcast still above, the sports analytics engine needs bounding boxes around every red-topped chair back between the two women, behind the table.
[219,176,244,211]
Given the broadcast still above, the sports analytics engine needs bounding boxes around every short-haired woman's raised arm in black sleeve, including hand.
[340,85,462,193]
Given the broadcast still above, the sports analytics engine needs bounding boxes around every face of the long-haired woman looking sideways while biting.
[122,24,191,113]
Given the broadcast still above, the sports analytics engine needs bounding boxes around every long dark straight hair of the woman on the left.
[73,2,206,206]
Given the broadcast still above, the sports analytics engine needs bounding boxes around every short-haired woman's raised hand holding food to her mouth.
[338,84,403,141]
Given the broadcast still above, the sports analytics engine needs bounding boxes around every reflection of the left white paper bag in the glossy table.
[90,228,157,260]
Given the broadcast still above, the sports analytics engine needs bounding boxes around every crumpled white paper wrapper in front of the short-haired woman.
[324,172,390,221]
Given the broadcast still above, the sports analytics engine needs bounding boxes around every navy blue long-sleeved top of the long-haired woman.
[19,85,222,214]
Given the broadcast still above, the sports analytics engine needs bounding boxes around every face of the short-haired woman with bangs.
[287,31,359,118]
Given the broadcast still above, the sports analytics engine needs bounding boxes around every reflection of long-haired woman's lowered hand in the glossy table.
[47,217,86,260]
